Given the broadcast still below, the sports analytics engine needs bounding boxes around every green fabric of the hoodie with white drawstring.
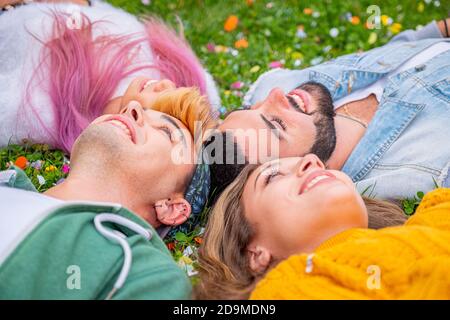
[0,168,191,299]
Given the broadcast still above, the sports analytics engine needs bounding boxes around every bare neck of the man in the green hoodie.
[45,170,158,227]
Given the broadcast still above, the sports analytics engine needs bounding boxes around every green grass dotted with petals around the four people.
[0,0,450,278]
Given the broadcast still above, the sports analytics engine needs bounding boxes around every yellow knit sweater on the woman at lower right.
[251,188,450,299]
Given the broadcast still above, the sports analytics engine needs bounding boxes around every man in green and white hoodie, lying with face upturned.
[0,104,209,299]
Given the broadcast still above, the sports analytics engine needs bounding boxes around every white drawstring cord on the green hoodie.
[94,213,153,300]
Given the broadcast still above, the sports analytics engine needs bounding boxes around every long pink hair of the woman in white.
[25,12,206,152]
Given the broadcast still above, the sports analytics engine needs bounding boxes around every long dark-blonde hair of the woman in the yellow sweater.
[194,165,406,299]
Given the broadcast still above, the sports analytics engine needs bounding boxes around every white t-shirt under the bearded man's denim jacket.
[334,42,450,110]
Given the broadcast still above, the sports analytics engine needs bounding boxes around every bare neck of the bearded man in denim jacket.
[327,116,366,170]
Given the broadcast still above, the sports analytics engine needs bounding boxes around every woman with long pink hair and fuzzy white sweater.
[0,0,220,152]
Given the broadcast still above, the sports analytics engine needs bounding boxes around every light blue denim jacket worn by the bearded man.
[244,22,450,199]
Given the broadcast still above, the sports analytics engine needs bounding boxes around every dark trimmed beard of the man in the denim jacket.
[298,81,336,162]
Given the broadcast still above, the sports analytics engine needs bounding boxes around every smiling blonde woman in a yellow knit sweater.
[195,155,450,299]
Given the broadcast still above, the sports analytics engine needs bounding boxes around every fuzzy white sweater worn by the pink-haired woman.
[0,1,220,147]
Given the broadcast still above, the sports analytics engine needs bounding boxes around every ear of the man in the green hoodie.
[155,198,192,226]
